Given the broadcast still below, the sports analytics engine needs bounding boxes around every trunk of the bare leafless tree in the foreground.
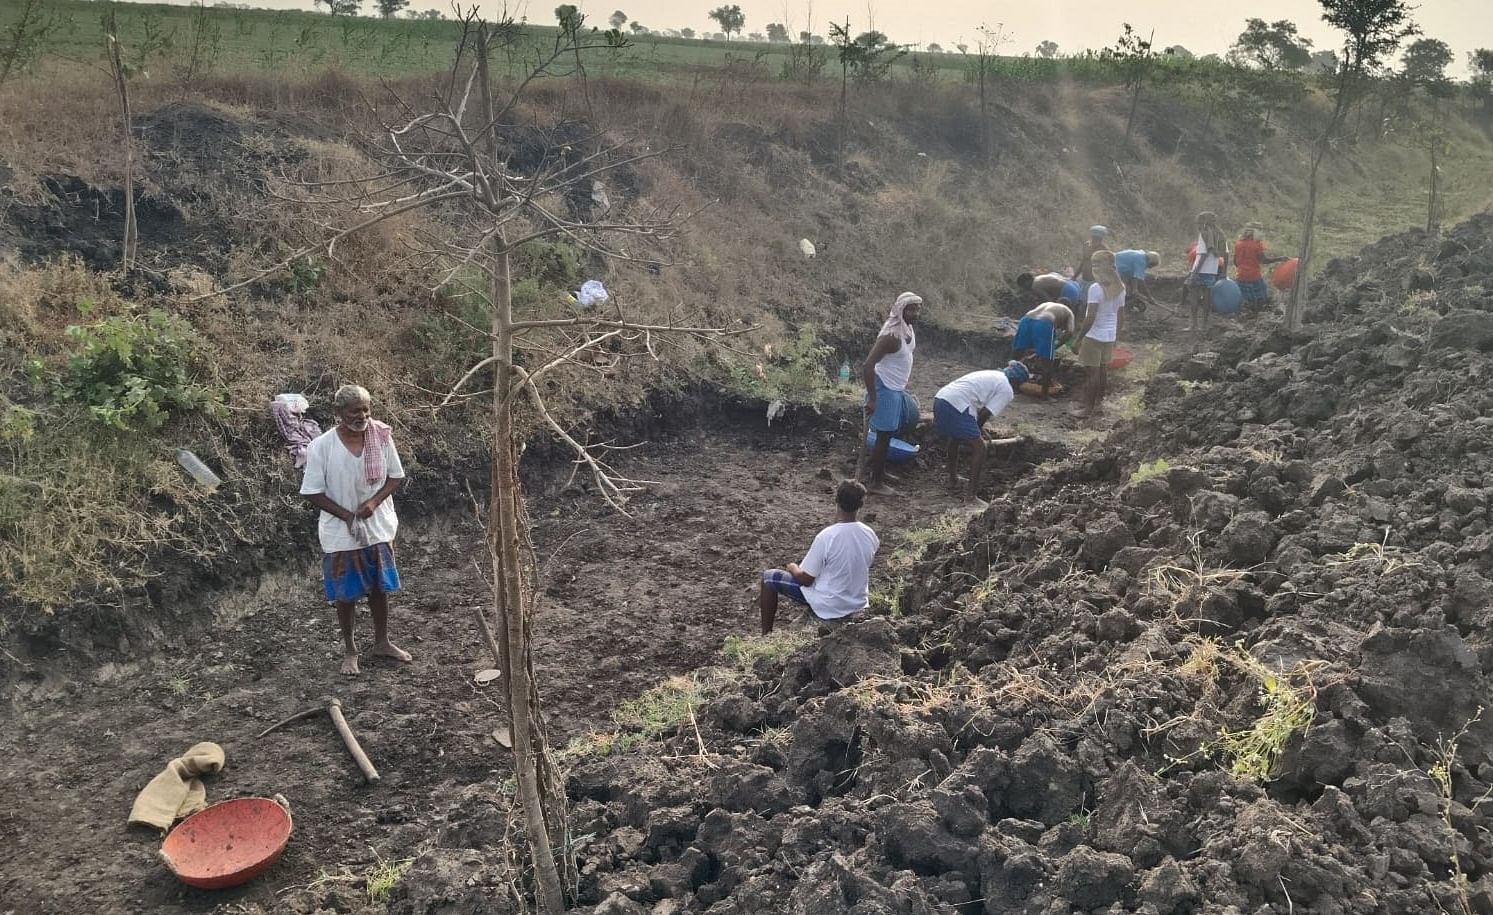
[478,27,564,915]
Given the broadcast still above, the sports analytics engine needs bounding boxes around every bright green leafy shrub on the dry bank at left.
[57,309,222,430]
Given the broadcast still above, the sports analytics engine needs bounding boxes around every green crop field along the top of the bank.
[0,0,1208,82]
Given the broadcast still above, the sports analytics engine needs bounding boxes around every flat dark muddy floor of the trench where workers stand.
[0,319,1152,915]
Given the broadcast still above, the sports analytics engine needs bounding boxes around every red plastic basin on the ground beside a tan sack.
[161,797,291,890]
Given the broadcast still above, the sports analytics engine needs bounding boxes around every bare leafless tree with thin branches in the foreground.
[203,9,749,915]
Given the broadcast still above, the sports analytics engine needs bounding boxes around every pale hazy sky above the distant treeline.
[192,0,1493,76]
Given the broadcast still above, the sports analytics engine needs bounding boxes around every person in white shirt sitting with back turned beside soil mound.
[757,479,881,636]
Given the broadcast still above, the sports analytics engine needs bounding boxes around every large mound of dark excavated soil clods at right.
[483,216,1493,915]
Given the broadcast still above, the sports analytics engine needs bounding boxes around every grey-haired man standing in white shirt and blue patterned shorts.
[300,385,409,676]
